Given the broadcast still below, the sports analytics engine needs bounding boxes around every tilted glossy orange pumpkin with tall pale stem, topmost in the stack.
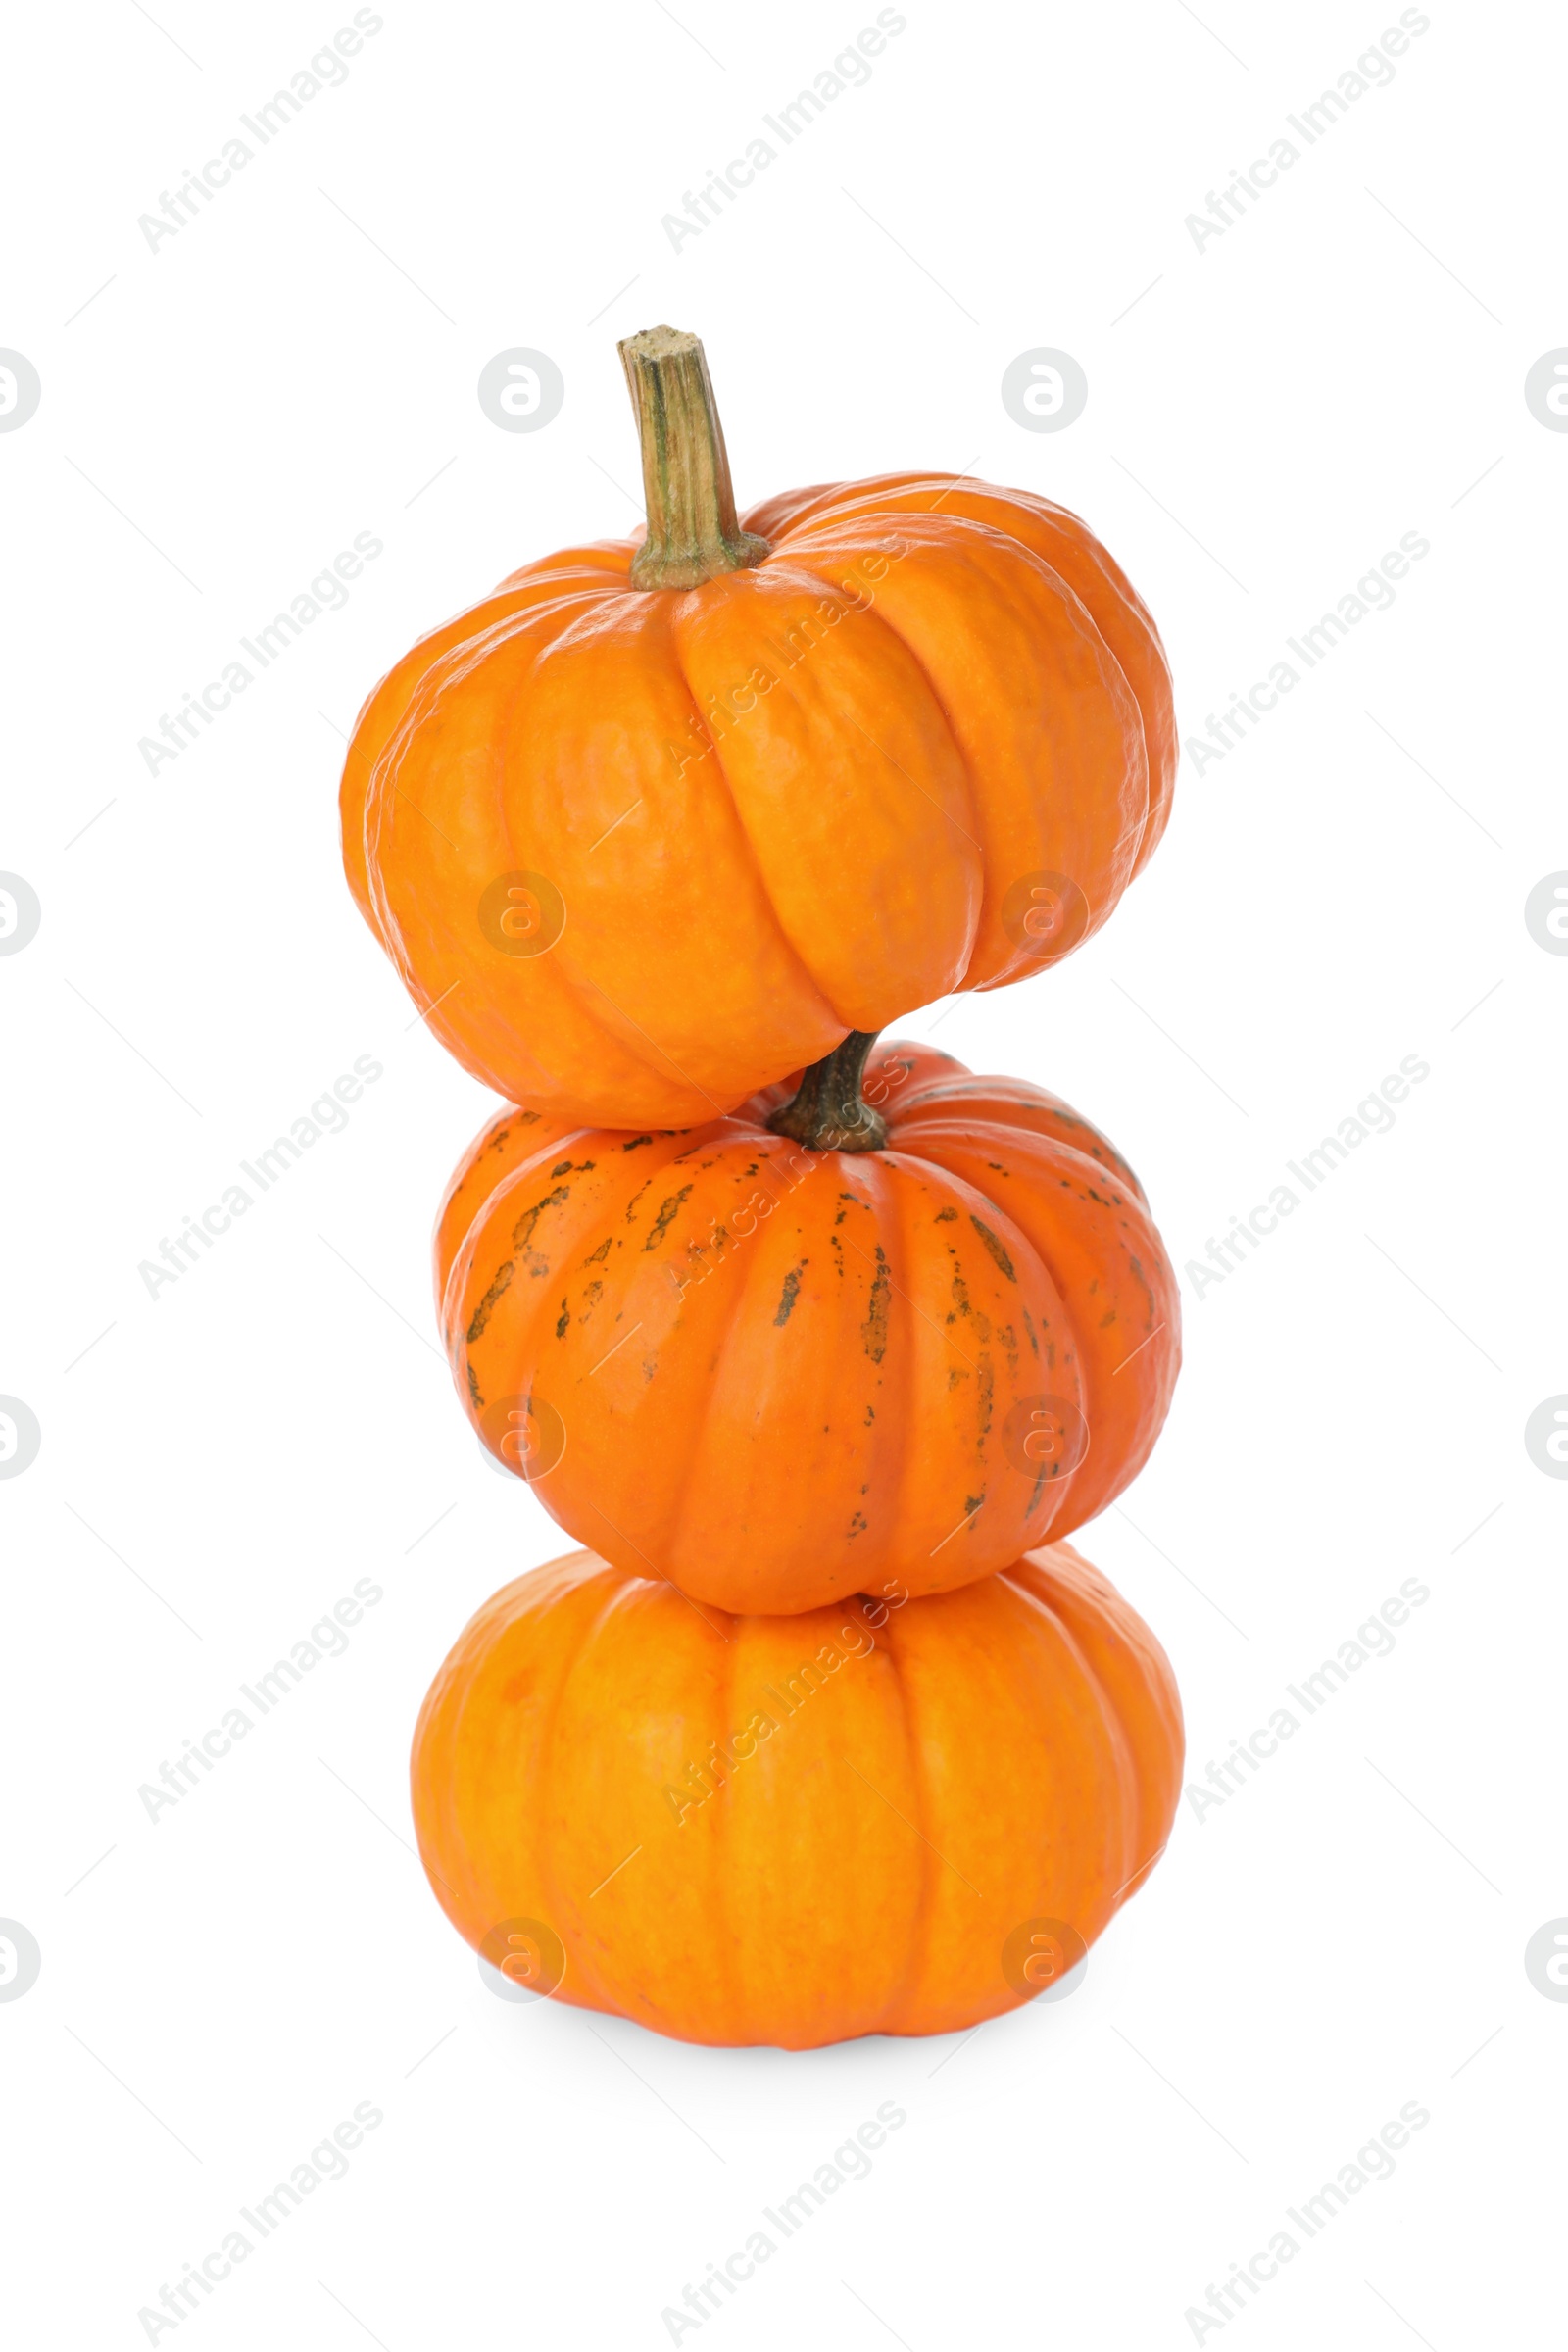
[341,327,1175,1127]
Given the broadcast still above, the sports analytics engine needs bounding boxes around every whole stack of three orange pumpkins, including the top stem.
[343,327,1183,2048]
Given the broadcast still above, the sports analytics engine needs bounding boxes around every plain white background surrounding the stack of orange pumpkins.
[0,0,1568,2352]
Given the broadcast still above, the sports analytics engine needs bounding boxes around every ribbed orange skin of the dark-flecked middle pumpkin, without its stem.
[435,1045,1180,1611]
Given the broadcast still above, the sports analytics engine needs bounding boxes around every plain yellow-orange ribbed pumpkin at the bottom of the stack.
[414,1543,1183,2048]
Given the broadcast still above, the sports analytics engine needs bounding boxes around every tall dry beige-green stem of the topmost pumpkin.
[615,327,768,588]
